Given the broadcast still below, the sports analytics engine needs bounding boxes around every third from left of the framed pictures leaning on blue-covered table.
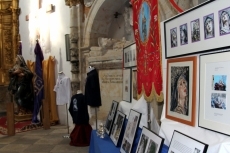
[120,109,141,153]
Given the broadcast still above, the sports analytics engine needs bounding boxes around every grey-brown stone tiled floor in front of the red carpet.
[0,126,89,153]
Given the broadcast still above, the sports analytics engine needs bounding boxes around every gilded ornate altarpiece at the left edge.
[0,0,20,85]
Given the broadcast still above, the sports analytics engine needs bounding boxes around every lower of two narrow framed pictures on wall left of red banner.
[123,68,132,102]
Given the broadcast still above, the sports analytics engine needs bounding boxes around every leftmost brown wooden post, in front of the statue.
[6,102,15,136]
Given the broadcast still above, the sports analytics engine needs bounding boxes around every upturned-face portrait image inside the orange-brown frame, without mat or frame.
[170,66,189,115]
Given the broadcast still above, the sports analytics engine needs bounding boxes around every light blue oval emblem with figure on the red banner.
[138,1,151,43]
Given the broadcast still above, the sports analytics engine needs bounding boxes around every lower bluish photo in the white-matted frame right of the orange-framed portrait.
[211,93,226,109]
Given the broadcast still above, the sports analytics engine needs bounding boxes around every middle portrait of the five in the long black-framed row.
[190,19,200,42]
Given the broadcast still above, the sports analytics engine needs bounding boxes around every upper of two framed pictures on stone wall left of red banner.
[123,43,137,68]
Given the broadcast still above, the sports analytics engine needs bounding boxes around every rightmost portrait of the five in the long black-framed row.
[219,7,230,36]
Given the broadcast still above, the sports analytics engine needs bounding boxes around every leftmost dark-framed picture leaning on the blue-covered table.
[105,100,119,135]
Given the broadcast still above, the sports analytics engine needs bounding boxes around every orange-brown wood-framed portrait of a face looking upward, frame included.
[166,56,197,126]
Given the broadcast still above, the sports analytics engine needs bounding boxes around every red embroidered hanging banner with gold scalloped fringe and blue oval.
[131,0,163,102]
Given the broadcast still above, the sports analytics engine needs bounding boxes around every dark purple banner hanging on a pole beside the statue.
[32,42,44,123]
